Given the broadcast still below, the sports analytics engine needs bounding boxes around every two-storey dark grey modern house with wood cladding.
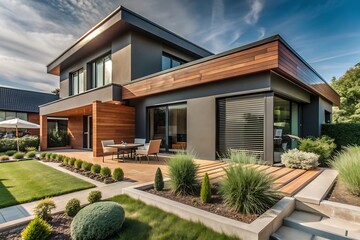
[40,6,339,163]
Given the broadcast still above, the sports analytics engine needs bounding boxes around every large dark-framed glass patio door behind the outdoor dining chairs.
[148,104,187,152]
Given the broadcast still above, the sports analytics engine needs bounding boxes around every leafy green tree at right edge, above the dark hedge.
[331,63,360,123]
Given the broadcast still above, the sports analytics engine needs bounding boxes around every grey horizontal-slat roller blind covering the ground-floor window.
[217,94,265,159]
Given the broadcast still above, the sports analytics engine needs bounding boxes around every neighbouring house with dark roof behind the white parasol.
[0,87,59,138]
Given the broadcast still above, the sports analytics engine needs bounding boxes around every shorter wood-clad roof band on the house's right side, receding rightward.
[277,42,340,105]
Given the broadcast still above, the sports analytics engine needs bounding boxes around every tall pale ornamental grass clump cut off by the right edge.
[331,146,360,196]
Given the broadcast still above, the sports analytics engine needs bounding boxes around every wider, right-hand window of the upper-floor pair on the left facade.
[91,55,112,88]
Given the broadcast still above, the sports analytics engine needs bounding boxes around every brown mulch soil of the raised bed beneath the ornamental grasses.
[144,188,259,223]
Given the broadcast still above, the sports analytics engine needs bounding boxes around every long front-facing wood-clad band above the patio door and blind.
[122,41,278,99]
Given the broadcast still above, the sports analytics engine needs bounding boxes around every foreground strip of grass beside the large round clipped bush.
[110,195,237,240]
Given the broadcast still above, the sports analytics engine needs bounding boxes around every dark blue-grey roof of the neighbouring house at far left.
[0,87,59,113]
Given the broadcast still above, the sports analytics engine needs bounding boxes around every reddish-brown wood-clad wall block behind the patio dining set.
[92,101,135,157]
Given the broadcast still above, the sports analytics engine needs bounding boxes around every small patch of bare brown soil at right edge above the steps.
[326,181,360,207]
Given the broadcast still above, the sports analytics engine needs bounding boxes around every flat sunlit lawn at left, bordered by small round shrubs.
[0,160,94,208]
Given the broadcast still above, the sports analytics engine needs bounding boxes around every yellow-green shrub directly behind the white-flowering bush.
[299,136,336,166]
